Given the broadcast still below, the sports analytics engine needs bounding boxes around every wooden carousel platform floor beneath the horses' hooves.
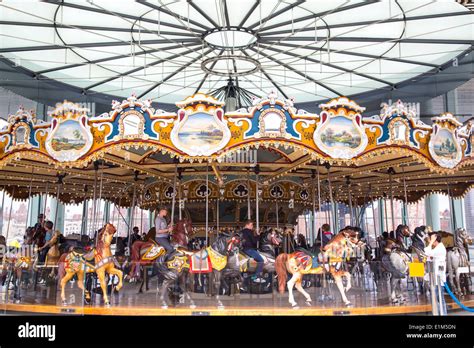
[0,283,474,316]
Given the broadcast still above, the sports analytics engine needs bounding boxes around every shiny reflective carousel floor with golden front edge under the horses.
[0,270,474,315]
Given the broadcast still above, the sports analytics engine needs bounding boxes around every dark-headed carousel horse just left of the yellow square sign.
[382,225,412,304]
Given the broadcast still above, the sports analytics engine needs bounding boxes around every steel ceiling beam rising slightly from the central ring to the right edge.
[261,11,472,36]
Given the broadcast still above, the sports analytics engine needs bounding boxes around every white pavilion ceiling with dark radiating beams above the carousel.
[0,0,474,106]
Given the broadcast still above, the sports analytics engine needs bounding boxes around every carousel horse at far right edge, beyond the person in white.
[446,228,473,295]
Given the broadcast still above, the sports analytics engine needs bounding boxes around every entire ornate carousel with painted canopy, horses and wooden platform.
[0,91,474,315]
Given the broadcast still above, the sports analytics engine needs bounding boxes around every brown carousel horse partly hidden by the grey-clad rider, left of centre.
[130,219,193,284]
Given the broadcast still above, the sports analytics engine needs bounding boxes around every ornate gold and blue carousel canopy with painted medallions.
[0,92,474,216]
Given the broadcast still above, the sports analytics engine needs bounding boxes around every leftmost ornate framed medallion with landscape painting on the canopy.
[45,102,93,162]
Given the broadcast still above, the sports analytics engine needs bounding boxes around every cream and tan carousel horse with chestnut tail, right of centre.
[275,227,361,308]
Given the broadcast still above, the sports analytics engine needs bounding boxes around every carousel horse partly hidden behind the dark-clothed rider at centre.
[239,229,281,273]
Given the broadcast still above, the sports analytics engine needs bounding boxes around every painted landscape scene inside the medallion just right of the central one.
[321,116,361,149]
